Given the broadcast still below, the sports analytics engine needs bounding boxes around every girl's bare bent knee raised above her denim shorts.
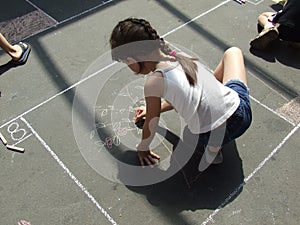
[214,47,247,84]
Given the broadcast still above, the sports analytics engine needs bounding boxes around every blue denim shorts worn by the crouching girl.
[199,80,252,146]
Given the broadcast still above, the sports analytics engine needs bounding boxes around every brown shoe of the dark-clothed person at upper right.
[250,27,279,50]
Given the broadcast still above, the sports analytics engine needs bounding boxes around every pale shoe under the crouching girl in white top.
[198,146,223,172]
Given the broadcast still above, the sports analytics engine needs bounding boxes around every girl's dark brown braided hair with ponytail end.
[110,18,197,86]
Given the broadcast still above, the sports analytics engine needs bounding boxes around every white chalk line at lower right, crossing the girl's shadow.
[202,123,300,225]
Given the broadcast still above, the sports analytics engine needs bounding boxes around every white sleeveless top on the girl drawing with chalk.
[155,61,240,134]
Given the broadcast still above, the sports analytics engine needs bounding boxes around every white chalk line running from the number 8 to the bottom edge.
[20,117,117,225]
